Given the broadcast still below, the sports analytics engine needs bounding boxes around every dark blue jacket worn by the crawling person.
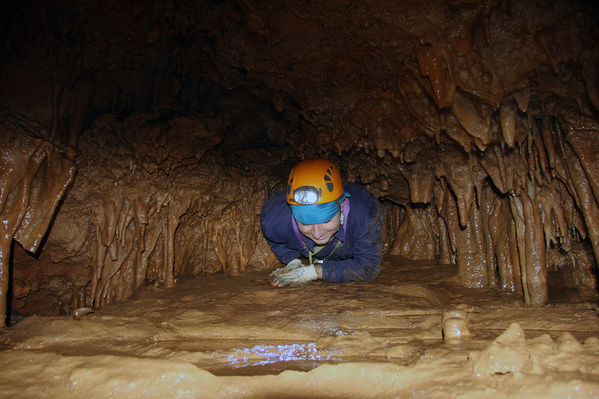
[260,183,383,283]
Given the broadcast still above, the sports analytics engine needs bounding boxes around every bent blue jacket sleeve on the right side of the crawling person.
[322,203,383,283]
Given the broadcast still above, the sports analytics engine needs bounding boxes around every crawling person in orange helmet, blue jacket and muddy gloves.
[261,159,383,287]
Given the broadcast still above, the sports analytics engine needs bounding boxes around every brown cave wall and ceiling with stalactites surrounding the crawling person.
[0,0,599,314]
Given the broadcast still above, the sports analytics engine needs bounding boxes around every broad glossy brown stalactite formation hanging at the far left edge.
[0,126,75,325]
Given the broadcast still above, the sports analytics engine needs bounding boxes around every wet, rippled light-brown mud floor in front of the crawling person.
[0,257,599,398]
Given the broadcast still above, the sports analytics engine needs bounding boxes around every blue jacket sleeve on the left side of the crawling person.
[260,193,301,263]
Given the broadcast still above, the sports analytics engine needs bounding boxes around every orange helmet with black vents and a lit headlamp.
[286,159,343,205]
